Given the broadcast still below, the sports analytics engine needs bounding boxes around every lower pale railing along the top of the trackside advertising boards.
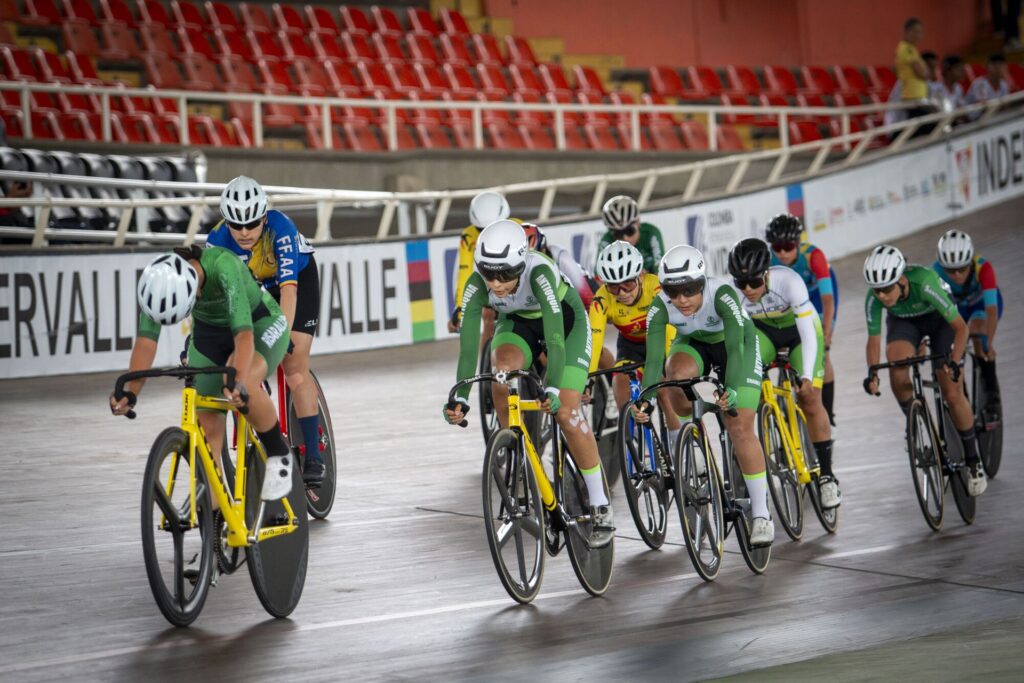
[0,91,1024,247]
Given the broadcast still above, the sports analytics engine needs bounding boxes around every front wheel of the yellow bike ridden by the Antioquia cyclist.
[482,429,546,603]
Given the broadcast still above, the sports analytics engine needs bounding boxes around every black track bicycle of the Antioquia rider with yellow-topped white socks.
[638,375,771,581]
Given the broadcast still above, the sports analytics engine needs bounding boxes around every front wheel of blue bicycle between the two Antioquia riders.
[615,401,672,550]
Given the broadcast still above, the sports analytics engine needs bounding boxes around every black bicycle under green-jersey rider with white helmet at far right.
[867,353,976,531]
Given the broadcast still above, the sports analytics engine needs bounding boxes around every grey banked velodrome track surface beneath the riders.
[0,200,1024,683]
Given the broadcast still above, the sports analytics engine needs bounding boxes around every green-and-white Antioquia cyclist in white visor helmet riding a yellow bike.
[444,220,614,547]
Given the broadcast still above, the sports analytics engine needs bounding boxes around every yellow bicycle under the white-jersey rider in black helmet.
[758,350,839,541]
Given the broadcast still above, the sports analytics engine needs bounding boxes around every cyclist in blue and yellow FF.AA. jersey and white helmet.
[206,175,325,483]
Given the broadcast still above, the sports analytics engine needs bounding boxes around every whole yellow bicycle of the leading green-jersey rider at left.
[114,366,309,627]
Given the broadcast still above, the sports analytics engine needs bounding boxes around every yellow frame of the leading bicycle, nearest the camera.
[161,386,298,548]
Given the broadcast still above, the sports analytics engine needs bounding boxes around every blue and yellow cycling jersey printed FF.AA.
[206,209,314,289]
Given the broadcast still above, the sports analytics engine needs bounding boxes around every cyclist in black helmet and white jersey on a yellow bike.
[729,238,842,508]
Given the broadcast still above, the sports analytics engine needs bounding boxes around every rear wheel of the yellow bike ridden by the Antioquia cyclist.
[559,454,615,596]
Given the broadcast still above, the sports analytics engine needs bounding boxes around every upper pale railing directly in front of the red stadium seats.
[0,82,922,152]
